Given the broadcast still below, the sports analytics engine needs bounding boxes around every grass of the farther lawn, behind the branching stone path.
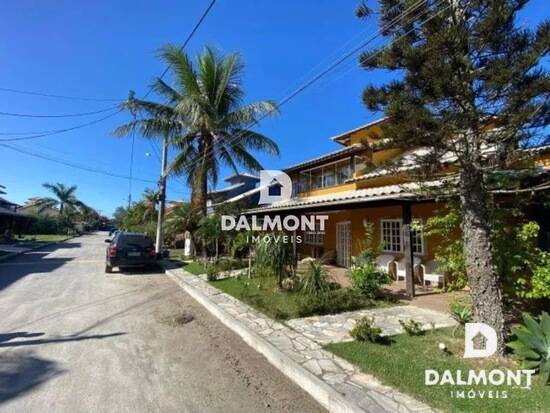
[210,276,393,320]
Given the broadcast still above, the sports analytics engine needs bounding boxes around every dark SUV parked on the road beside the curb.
[105,231,157,273]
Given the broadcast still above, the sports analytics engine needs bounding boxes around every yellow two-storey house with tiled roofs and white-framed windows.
[246,119,550,284]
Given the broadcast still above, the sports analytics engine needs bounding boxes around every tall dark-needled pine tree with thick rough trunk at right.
[357,0,550,354]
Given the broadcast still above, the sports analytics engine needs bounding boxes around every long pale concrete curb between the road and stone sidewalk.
[165,270,365,413]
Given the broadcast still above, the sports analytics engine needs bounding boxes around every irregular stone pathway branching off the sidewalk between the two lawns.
[286,305,456,345]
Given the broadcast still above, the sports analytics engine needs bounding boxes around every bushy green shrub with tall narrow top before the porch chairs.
[350,223,392,298]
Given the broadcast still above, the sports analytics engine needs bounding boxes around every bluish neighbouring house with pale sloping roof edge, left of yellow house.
[207,173,276,214]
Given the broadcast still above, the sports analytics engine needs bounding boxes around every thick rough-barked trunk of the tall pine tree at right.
[460,167,505,355]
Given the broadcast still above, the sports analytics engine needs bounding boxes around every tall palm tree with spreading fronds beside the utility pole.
[115,45,279,217]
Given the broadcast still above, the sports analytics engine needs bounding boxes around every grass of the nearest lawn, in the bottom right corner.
[326,329,550,413]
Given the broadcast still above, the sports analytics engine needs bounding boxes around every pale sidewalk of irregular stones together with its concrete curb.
[162,269,433,413]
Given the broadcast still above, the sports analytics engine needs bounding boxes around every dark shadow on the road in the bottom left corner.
[0,351,64,404]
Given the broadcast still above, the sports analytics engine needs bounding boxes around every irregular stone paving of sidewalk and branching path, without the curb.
[169,270,440,413]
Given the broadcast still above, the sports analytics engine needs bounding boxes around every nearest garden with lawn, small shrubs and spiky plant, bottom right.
[325,308,550,413]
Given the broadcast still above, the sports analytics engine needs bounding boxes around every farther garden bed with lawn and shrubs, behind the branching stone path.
[201,225,397,320]
